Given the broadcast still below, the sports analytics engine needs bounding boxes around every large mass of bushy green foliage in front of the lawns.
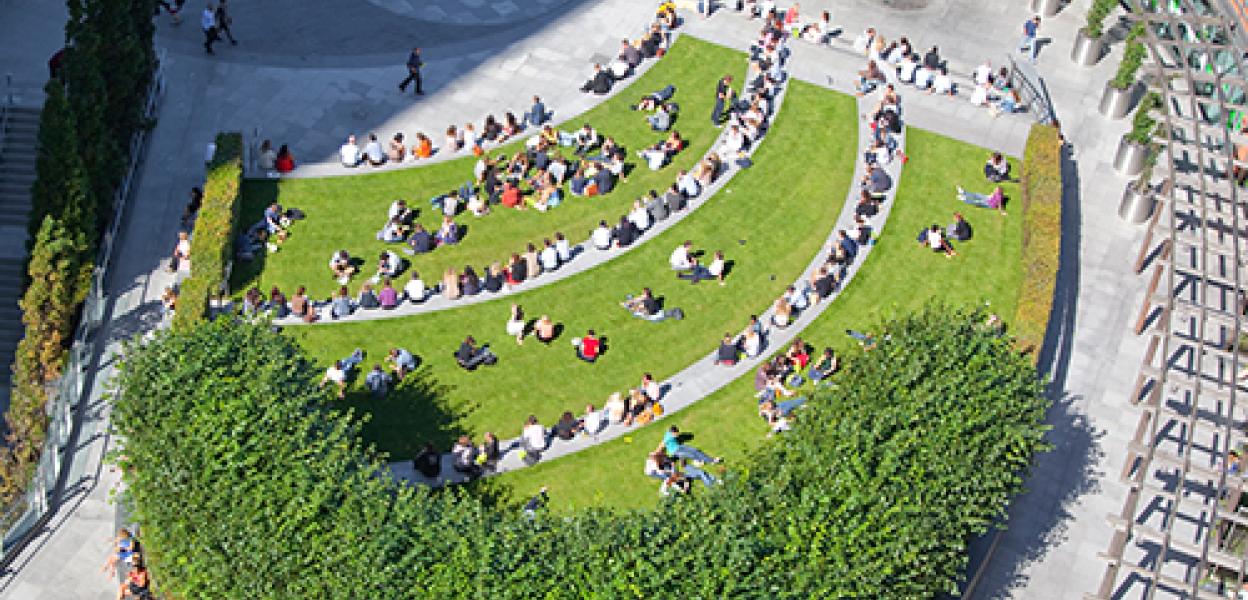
[112,306,1047,599]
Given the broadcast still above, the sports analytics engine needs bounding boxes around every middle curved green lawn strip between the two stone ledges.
[288,84,857,459]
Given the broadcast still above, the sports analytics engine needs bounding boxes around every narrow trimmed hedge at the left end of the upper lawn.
[173,133,242,328]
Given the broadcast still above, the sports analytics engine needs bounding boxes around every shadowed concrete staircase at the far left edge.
[0,106,40,410]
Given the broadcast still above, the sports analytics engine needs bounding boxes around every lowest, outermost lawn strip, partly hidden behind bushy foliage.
[484,125,1022,510]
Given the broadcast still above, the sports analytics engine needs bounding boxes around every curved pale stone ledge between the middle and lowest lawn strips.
[388,81,905,485]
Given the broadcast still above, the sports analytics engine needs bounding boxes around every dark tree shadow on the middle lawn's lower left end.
[333,358,477,460]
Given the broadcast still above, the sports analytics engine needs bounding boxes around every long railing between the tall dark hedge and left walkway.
[0,51,165,556]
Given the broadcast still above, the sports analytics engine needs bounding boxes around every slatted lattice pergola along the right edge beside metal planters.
[1086,0,1248,599]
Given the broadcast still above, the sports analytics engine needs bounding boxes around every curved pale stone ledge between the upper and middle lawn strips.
[273,39,789,327]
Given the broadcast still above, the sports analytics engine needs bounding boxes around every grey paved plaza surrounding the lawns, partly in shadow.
[0,0,1168,599]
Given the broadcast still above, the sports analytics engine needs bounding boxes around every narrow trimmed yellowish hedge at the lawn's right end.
[1013,125,1062,349]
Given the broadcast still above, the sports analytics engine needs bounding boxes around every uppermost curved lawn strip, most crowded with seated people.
[231,36,745,297]
